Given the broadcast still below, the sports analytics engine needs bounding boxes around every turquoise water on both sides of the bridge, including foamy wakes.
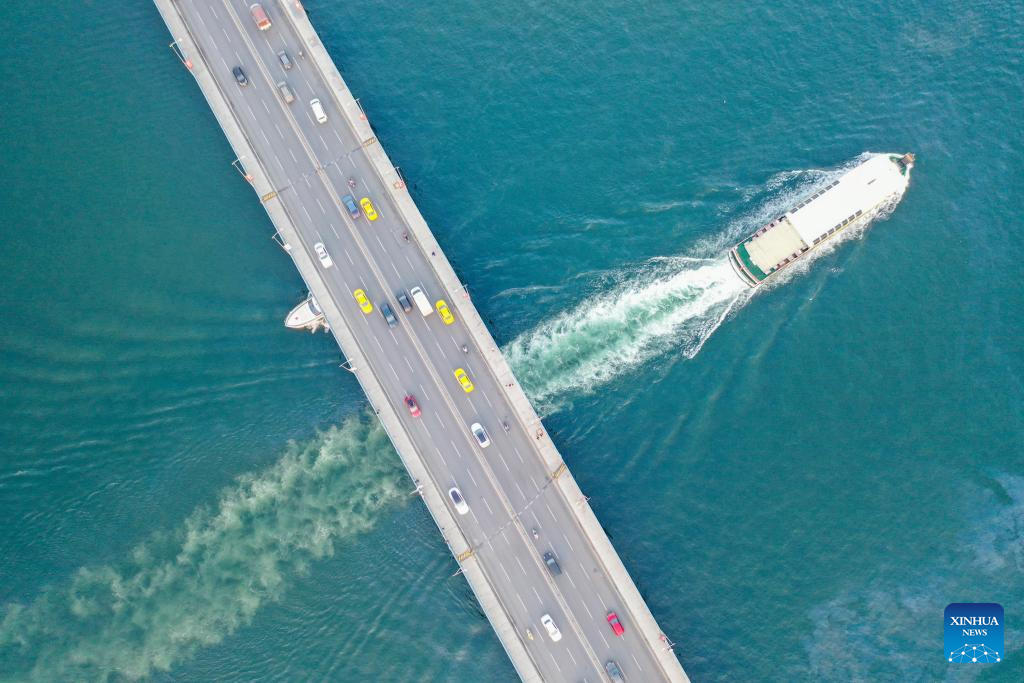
[0,0,1024,681]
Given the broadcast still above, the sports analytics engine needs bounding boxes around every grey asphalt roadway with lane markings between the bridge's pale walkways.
[178,0,662,681]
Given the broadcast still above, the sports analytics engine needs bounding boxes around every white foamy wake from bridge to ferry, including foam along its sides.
[505,153,895,414]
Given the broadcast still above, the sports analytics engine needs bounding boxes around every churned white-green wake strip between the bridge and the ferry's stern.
[505,256,749,410]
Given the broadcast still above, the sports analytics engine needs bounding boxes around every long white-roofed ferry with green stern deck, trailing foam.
[729,154,913,287]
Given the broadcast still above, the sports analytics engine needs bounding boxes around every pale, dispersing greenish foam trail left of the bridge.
[0,418,409,681]
